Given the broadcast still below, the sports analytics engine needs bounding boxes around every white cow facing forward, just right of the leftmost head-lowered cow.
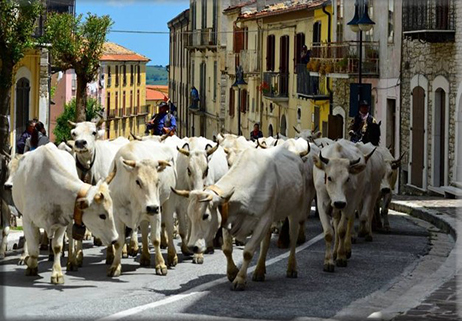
[108,140,178,276]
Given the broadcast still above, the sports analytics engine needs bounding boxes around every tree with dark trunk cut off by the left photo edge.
[0,0,42,155]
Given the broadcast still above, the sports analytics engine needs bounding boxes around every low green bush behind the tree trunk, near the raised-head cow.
[53,97,103,144]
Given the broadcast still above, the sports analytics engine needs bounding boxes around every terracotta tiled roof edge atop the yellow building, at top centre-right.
[240,0,327,19]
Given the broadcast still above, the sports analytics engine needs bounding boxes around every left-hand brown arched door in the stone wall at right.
[411,87,425,188]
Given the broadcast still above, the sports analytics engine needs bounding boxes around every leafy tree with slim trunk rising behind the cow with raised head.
[44,13,112,122]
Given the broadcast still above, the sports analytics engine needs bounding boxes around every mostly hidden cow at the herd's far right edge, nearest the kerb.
[375,147,404,232]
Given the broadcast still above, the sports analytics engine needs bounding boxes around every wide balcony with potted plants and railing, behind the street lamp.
[307,41,380,77]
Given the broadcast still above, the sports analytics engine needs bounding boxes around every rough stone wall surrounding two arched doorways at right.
[400,38,460,193]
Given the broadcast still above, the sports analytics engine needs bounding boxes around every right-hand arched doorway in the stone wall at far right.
[432,88,447,187]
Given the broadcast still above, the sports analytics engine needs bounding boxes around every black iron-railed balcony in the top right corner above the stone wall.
[403,0,456,42]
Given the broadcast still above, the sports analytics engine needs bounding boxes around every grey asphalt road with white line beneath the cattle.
[0,210,430,320]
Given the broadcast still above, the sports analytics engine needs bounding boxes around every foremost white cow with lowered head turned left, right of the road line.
[176,146,307,290]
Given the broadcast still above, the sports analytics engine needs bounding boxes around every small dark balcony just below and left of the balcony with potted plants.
[297,64,329,100]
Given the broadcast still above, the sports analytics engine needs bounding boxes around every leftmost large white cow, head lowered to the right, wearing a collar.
[13,143,118,284]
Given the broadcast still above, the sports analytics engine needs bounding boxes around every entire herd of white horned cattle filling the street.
[0,122,401,290]
